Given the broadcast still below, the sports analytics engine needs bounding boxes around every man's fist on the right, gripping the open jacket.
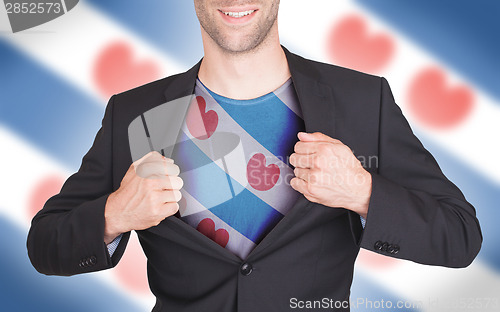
[290,132,372,218]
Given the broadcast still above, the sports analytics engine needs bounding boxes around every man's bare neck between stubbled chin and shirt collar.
[198,30,290,100]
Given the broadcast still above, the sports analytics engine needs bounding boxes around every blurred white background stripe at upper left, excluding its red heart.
[0,2,185,103]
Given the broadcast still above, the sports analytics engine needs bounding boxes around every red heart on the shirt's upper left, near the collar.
[186,96,219,140]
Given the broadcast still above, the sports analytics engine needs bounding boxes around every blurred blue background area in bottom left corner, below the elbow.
[0,217,142,312]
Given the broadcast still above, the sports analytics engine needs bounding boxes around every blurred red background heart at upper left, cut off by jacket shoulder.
[94,42,160,97]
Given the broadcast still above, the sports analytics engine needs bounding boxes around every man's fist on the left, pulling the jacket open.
[104,152,183,244]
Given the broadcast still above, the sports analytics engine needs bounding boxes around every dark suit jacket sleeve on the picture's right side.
[358,78,482,267]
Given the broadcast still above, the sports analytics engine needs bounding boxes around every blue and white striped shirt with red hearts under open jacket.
[172,79,304,259]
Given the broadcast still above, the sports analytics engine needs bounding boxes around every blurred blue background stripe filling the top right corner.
[356,0,500,103]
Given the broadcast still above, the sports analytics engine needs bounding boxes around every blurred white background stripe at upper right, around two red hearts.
[279,0,500,186]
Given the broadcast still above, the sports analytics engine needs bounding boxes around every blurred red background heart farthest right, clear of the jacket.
[408,68,474,128]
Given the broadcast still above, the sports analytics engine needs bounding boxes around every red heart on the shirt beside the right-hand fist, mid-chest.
[247,153,280,191]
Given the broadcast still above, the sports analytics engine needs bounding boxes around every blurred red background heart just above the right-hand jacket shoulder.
[328,16,394,73]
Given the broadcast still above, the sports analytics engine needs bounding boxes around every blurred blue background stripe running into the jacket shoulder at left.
[0,40,104,170]
